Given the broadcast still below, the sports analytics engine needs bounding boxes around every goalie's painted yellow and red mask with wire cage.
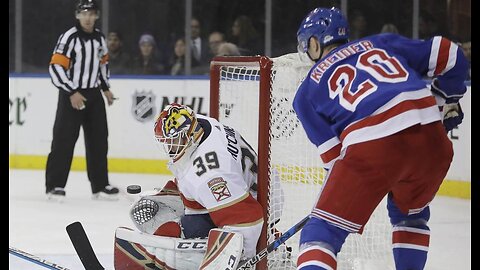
[154,103,203,162]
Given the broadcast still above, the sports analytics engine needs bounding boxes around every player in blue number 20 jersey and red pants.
[293,5,468,270]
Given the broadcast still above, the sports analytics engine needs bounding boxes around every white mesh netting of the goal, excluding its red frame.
[214,53,393,270]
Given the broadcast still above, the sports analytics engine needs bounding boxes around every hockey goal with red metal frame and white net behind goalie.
[210,53,394,270]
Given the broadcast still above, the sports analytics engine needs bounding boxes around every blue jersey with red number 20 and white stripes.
[293,33,468,168]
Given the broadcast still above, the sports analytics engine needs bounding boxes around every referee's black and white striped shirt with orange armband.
[49,24,110,95]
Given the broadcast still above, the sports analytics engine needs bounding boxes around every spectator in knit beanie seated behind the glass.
[132,34,165,75]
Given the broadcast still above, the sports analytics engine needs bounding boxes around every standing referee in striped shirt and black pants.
[45,0,119,201]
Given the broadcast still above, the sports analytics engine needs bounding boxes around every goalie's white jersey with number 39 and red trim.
[169,115,263,256]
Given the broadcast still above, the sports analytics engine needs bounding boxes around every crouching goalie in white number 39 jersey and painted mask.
[114,103,283,270]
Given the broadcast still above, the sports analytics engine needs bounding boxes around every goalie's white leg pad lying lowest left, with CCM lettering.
[114,227,207,270]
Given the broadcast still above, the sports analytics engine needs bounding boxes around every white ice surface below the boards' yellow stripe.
[9,170,471,270]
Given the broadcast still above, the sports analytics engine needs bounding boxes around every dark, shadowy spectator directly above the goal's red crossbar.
[229,15,263,55]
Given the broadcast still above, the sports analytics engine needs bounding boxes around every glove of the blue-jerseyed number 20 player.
[430,79,464,132]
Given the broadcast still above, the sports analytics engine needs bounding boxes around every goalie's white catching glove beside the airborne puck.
[130,181,184,237]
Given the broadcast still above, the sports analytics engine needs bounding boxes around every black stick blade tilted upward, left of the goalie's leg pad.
[67,221,105,270]
